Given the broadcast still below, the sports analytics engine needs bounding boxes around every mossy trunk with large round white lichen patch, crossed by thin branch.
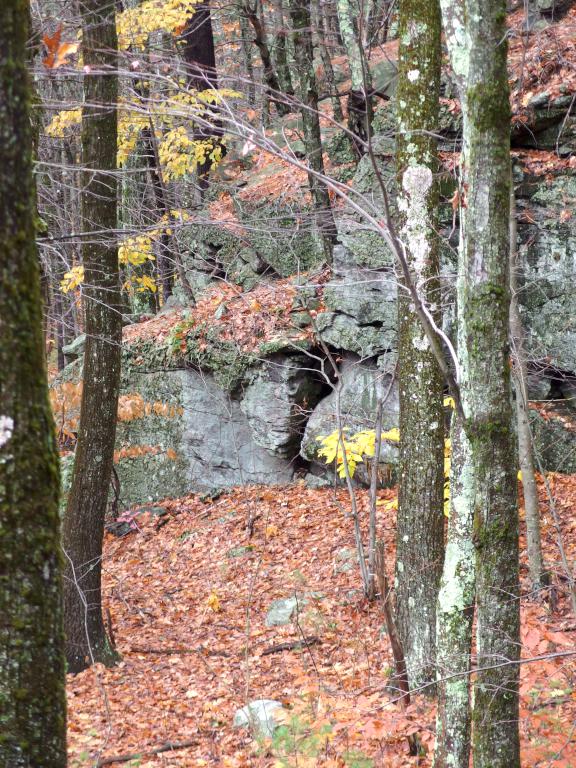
[396,0,444,691]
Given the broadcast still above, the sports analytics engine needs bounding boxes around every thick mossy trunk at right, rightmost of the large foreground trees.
[441,0,520,768]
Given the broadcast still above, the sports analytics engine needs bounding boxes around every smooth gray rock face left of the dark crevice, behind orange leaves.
[59,354,321,506]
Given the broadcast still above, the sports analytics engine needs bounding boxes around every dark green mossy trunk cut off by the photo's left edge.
[0,0,66,768]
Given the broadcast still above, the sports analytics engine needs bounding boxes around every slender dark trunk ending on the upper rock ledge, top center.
[289,0,337,262]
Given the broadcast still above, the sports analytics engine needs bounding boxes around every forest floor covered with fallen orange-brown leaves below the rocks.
[68,475,576,768]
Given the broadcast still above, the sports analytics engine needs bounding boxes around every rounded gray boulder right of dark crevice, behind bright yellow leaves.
[300,356,399,479]
